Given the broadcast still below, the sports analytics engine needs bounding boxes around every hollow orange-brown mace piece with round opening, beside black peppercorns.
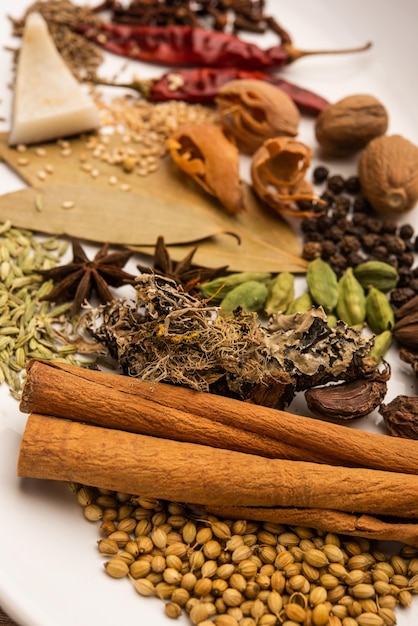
[251,137,316,217]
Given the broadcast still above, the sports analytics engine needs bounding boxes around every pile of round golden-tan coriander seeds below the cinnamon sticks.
[70,483,418,626]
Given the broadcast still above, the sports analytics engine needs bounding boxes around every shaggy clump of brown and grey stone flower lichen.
[84,274,372,408]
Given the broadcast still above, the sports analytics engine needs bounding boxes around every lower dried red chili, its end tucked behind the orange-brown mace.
[94,67,329,115]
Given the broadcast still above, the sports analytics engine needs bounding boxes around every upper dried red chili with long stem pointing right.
[77,22,371,71]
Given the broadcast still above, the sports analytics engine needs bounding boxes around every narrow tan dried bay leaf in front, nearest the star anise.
[0,185,221,246]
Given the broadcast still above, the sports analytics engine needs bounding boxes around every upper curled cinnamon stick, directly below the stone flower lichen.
[21,360,418,474]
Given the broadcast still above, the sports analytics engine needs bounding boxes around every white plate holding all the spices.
[0,0,418,626]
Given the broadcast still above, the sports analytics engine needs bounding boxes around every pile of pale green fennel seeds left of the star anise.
[0,221,90,399]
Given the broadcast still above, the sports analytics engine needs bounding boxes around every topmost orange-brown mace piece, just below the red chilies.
[215,79,300,154]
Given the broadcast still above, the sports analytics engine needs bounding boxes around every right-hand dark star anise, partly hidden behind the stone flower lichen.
[137,236,228,293]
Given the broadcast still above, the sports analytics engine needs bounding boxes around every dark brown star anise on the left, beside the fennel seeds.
[38,239,135,316]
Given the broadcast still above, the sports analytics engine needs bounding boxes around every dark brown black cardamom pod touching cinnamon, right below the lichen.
[305,376,387,421]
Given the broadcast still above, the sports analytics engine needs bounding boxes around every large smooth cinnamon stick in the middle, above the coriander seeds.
[18,414,418,519]
